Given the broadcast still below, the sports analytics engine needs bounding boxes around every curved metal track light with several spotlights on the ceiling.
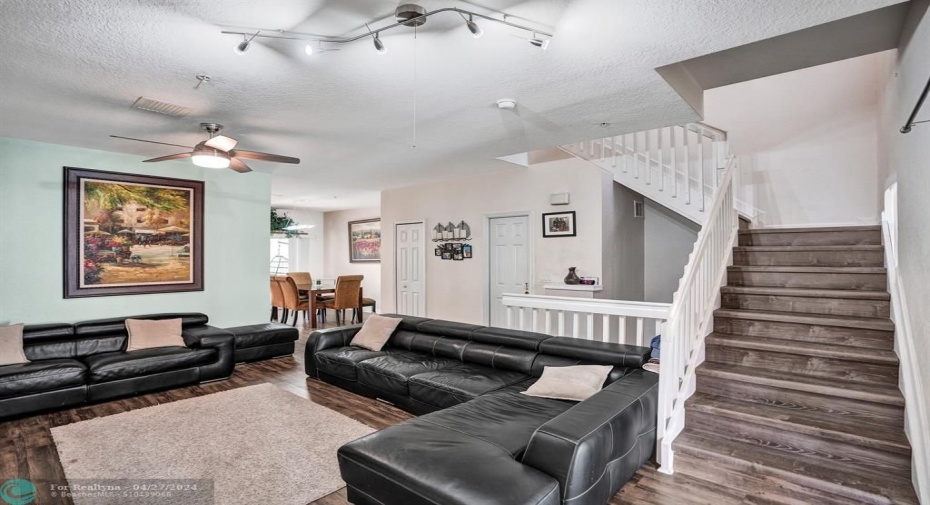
[221,4,552,56]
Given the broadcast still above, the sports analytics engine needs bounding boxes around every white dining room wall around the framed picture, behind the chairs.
[322,207,387,312]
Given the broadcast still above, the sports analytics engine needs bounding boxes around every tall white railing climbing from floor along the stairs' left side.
[657,157,739,473]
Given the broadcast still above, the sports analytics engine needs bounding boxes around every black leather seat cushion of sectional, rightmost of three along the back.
[408,363,529,408]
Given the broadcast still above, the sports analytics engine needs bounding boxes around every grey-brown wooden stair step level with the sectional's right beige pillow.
[696,362,904,407]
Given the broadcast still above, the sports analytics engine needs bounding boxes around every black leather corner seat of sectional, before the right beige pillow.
[418,391,575,459]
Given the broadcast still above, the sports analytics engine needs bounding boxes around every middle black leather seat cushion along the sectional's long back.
[358,351,461,396]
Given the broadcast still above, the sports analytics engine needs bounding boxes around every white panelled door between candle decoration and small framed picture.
[488,216,530,327]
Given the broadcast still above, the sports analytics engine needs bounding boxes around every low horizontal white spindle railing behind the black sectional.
[503,294,671,346]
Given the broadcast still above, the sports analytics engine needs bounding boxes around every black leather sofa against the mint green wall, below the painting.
[0,313,235,419]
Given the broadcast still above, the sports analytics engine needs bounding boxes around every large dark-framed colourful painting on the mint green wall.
[64,167,203,298]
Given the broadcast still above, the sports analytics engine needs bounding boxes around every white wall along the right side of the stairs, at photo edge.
[880,0,930,503]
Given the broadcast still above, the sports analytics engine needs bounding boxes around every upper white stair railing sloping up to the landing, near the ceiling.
[562,123,728,224]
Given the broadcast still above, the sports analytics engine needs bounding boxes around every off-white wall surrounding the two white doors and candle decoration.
[376,159,606,324]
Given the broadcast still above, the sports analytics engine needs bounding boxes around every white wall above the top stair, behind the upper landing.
[704,52,888,226]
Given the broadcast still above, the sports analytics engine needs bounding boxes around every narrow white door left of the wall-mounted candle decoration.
[394,223,426,317]
